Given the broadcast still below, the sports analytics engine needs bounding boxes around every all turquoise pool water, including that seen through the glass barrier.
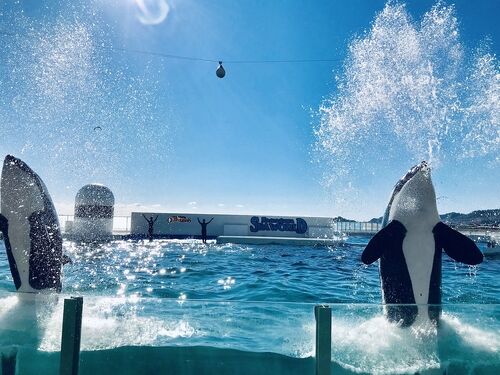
[0,236,500,375]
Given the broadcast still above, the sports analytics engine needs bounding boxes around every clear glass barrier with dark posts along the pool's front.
[0,293,500,375]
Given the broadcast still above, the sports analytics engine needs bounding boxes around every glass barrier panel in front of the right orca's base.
[331,304,500,374]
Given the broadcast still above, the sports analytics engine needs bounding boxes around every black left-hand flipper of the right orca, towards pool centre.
[361,220,406,264]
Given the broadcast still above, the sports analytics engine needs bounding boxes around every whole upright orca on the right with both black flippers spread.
[361,161,483,327]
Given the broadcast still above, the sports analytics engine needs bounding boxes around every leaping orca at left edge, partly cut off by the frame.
[0,155,65,293]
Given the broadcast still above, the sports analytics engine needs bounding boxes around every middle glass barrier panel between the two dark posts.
[76,297,315,375]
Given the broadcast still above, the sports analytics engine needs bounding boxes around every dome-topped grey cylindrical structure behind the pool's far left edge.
[70,184,115,242]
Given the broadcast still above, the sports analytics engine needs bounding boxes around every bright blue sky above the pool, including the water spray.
[0,0,500,220]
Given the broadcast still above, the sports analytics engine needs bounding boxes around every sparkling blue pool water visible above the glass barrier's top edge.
[0,236,488,304]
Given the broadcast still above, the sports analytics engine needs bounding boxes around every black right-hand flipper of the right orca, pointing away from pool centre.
[432,222,483,265]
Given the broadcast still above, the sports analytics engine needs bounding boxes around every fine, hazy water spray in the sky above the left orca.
[0,4,171,186]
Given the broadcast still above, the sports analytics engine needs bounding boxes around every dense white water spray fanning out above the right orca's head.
[314,2,500,194]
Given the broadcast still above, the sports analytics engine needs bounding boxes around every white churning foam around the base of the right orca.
[324,309,500,374]
